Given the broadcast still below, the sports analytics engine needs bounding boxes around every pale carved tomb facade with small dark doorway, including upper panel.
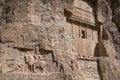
[64,0,99,57]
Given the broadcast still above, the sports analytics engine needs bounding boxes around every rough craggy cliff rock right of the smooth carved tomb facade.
[99,0,120,80]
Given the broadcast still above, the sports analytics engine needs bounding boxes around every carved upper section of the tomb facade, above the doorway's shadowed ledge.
[65,0,95,27]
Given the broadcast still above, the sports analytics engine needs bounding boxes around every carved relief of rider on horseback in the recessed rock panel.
[25,46,46,73]
